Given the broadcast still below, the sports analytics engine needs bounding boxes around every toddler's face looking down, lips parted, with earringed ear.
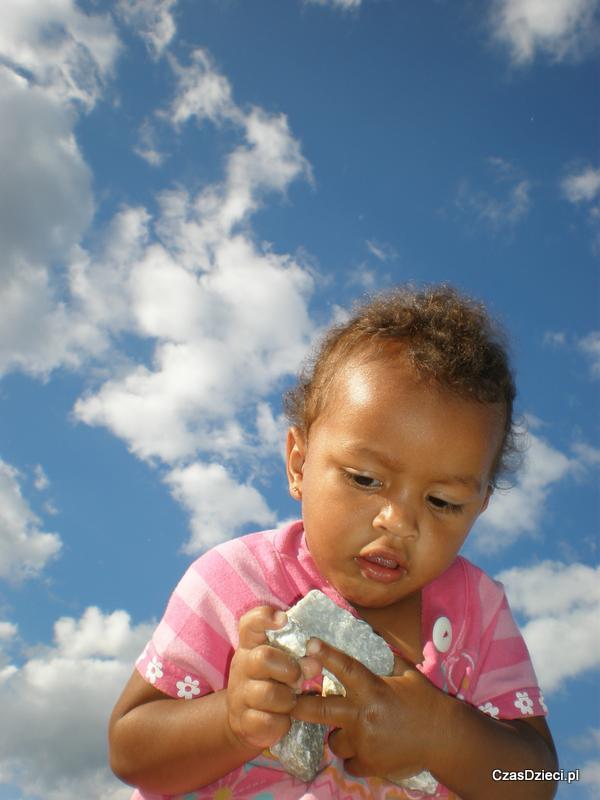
[287,357,503,608]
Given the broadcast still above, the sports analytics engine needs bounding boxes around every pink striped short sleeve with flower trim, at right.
[467,574,547,719]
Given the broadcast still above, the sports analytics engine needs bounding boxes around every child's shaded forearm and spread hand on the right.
[292,643,556,800]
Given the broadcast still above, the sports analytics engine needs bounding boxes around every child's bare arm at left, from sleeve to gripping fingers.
[109,607,320,794]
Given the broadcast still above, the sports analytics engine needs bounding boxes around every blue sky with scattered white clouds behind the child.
[0,0,600,800]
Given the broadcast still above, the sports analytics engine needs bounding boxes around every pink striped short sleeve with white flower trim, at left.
[136,534,289,700]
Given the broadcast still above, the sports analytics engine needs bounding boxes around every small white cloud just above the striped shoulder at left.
[166,463,276,553]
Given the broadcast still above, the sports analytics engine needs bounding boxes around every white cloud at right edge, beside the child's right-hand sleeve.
[497,561,600,692]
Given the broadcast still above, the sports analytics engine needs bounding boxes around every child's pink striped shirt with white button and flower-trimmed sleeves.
[132,521,546,800]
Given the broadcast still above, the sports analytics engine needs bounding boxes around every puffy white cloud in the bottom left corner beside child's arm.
[0,607,151,800]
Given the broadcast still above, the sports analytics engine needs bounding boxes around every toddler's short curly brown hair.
[284,284,521,487]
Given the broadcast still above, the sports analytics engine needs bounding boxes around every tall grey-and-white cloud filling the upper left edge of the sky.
[0,0,119,374]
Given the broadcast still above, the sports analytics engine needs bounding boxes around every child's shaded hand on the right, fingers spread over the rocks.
[292,640,445,779]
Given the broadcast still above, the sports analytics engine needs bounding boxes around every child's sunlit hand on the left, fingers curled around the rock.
[227,606,320,749]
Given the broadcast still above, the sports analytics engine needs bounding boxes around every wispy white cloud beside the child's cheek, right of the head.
[473,433,579,552]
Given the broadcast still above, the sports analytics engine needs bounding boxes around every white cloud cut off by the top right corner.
[491,0,598,65]
